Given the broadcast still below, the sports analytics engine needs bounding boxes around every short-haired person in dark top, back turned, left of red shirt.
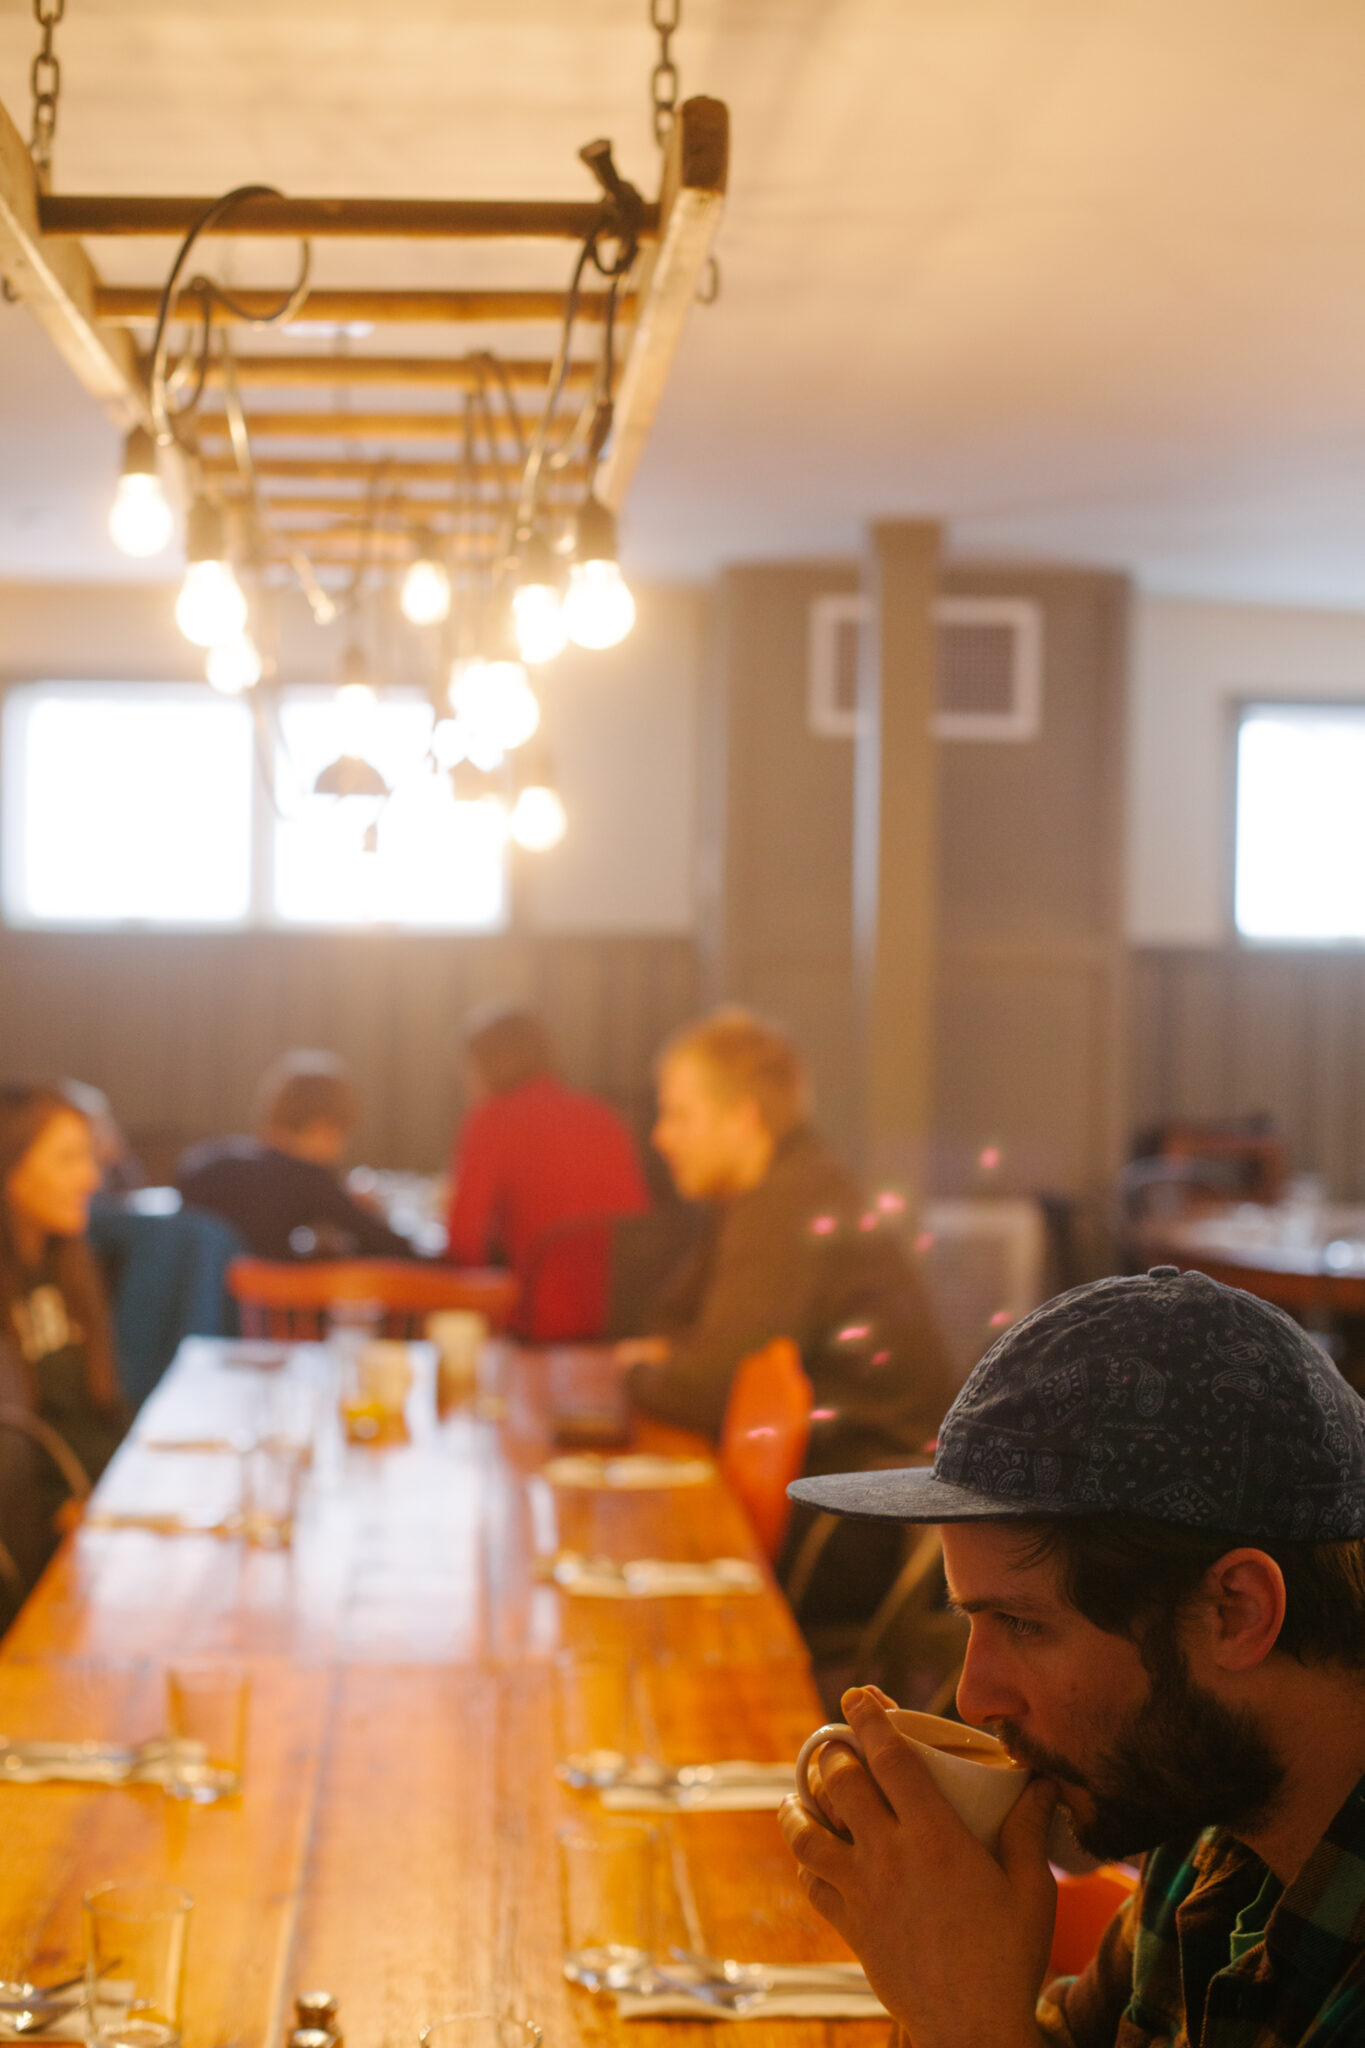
[176,1053,413,1260]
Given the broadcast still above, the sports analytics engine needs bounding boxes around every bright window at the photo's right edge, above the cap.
[1236,705,1365,944]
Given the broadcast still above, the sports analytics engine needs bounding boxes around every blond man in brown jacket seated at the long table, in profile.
[618,1008,952,1618]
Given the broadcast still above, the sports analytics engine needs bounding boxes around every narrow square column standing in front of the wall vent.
[853,520,939,1208]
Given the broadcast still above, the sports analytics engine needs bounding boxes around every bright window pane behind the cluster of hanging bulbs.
[272,690,505,930]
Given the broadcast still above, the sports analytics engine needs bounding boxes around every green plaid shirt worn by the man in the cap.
[1038,1778,1365,2048]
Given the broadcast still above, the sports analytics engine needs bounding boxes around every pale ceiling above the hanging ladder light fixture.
[0,0,1365,604]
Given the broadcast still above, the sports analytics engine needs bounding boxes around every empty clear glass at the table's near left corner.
[84,1882,194,2048]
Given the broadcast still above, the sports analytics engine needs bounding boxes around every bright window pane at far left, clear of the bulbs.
[4,684,252,924]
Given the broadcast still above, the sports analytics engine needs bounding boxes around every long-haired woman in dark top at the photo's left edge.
[0,1081,125,1606]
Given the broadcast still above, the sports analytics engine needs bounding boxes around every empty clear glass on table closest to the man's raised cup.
[559,1821,659,1991]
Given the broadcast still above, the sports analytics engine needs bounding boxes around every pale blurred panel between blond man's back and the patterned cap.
[915,1196,1048,1382]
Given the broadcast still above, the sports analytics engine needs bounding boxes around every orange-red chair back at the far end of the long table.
[227,1260,518,1343]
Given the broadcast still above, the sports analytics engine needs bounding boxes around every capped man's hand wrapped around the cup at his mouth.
[780,1688,1056,2048]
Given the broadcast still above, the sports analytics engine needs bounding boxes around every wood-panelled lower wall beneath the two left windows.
[0,930,698,1178]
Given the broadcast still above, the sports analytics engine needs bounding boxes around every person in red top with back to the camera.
[448,1008,649,1343]
